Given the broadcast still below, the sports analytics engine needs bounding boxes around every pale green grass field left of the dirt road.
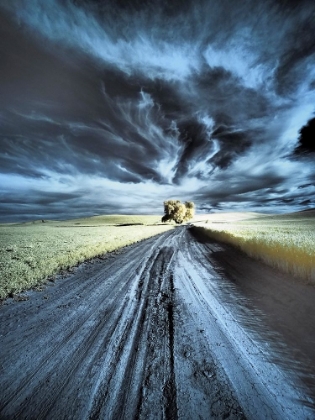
[0,215,173,299]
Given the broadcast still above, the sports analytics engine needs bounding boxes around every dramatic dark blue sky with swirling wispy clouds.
[0,0,315,222]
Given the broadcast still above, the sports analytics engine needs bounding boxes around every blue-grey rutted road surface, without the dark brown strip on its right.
[0,227,311,420]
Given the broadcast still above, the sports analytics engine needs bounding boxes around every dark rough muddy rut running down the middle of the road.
[135,247,177,419]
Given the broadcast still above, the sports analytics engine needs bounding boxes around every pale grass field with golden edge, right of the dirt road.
[195,210,315,284]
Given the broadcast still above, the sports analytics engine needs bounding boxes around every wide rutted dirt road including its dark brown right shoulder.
[0,227,315,420]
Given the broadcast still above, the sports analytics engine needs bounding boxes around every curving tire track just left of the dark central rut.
[90,251,174,419]
